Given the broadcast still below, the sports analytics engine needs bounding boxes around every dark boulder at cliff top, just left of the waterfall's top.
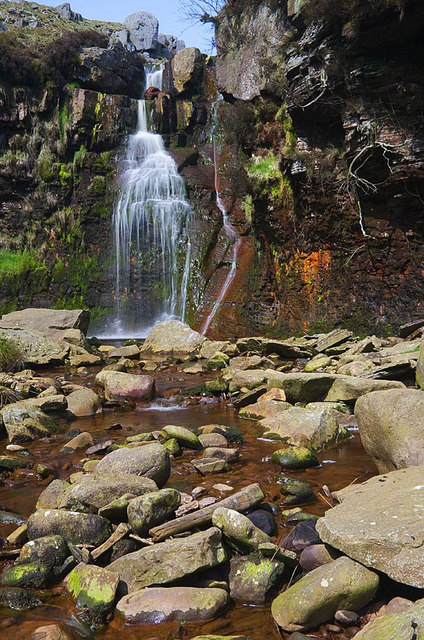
[74,45,145,98]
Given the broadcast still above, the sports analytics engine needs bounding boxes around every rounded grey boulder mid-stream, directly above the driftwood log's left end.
[96,443,171,493]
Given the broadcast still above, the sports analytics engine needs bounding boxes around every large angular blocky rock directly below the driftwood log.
[108,527,227,593]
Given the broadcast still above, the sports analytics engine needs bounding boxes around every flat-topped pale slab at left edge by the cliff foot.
[0,309,90,342]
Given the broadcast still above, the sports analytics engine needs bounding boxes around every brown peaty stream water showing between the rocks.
[0,366,376,640]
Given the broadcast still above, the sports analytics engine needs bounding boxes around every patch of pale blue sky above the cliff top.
[30,0,211,53]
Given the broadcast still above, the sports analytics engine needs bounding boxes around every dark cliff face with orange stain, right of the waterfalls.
[216,0,424,338]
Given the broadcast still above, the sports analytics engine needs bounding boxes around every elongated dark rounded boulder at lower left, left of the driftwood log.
[27,509,112,546]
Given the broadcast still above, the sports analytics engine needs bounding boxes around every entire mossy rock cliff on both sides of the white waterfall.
[0,0,424,335]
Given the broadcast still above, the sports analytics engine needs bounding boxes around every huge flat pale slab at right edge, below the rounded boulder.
[316,465,424,589]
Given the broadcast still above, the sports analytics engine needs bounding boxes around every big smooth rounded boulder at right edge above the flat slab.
[355,389,424,473]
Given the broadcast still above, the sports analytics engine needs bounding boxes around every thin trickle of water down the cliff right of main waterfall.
[201,95,241,335]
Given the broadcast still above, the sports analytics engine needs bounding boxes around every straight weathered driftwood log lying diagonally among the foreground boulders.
[149,484,264,542]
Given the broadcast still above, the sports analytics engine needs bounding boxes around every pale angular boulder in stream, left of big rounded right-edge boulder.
[260,407,347,448]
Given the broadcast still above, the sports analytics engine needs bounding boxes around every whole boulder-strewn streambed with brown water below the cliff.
[0,312,424,640]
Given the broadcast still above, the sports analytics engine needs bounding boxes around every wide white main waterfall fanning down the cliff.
[113,65,191,337]
